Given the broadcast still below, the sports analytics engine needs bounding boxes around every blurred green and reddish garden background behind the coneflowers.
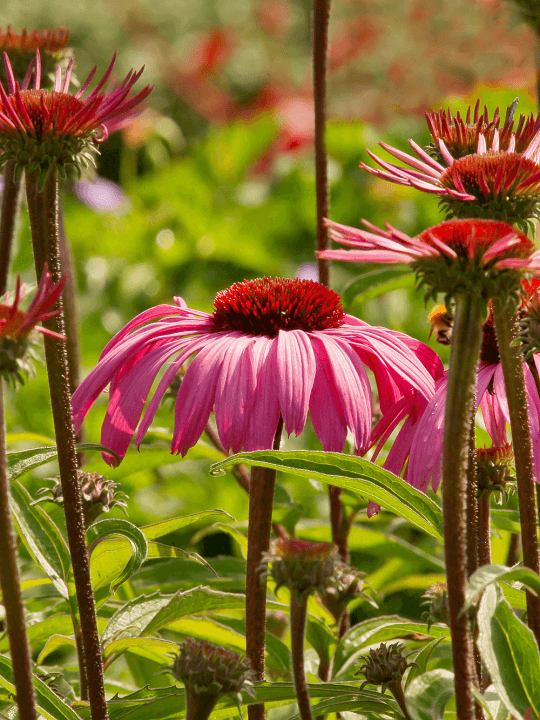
[0,0,535,696]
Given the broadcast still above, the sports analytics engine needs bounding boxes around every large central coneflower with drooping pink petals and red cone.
[73,278,436,462]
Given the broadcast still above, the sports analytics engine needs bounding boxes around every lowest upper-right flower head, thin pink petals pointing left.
[318,220,540,297]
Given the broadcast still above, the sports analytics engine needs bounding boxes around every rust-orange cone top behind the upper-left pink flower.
[0,25,72,85]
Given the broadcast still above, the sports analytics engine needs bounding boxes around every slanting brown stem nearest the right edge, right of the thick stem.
[492,298,540,643]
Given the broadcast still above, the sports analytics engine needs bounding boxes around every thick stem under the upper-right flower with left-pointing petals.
[442,295,485,720]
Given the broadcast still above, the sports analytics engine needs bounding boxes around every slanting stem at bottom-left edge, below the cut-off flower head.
[0,378,38,720]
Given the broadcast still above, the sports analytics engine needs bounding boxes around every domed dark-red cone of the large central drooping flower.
[213,277,343,337]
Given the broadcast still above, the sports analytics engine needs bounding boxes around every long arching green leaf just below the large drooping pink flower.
[210,450,442,539]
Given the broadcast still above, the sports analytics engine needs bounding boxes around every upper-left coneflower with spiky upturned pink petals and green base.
[0,50,151,179]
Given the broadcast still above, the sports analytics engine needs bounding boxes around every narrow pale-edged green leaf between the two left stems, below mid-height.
[10,480,71,599]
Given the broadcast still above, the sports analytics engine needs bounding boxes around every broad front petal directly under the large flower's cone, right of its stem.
[277,330,317,435]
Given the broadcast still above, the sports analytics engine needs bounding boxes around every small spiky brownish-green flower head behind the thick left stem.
[37,470,127,529]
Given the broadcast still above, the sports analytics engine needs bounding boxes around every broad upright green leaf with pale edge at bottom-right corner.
[477,585,540,720]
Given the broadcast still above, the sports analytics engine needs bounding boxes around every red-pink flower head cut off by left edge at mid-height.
[0,267,65,382]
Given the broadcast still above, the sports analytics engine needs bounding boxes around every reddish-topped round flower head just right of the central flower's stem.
[261,537,340,598]
